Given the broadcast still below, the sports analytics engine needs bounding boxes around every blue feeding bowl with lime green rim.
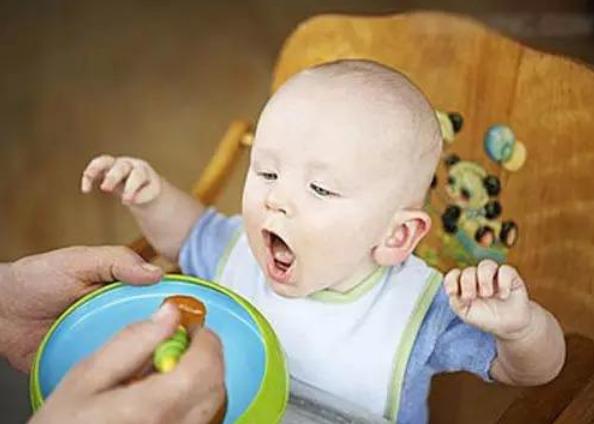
[31,276,288,423]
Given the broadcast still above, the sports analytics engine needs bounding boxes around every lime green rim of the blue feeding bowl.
[29,274,289,424]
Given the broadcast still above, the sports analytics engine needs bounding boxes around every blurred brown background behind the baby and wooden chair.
[0,0,594,422]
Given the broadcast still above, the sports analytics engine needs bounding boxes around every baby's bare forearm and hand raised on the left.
[81,155,204,261]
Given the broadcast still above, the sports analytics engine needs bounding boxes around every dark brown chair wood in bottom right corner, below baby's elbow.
[498,334,594,424]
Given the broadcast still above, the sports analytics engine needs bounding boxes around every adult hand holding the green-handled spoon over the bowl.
[30,303,225,424]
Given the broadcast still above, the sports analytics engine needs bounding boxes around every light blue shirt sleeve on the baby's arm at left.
[179,208,242,280]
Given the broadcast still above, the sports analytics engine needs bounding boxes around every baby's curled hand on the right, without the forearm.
[444,260,531,339]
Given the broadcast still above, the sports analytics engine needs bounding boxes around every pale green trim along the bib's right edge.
[384,271,442,422]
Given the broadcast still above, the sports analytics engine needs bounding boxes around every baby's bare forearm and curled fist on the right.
[444,260,565,385]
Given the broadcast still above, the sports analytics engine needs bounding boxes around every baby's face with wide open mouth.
[243,76,407,297]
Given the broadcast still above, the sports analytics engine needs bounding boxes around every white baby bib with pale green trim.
[215,232,441,421]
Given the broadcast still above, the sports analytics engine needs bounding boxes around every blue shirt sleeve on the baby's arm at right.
[428,289,497,381]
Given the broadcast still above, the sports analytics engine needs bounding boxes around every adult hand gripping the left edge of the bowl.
[0,246,163,372]
